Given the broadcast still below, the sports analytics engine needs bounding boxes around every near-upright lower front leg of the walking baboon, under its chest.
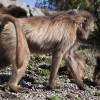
[49,52,62,89]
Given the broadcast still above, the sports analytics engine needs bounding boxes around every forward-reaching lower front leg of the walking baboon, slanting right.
[64,51,84,90]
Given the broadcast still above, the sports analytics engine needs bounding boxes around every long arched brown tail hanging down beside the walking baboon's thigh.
[2,14,24,68]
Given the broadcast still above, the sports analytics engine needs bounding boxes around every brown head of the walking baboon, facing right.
[76,11,94,39]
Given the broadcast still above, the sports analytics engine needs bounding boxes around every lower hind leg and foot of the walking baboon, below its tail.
[8,40,30,92]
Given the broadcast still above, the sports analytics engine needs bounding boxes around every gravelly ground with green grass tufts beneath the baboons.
[0,42,100,100]
